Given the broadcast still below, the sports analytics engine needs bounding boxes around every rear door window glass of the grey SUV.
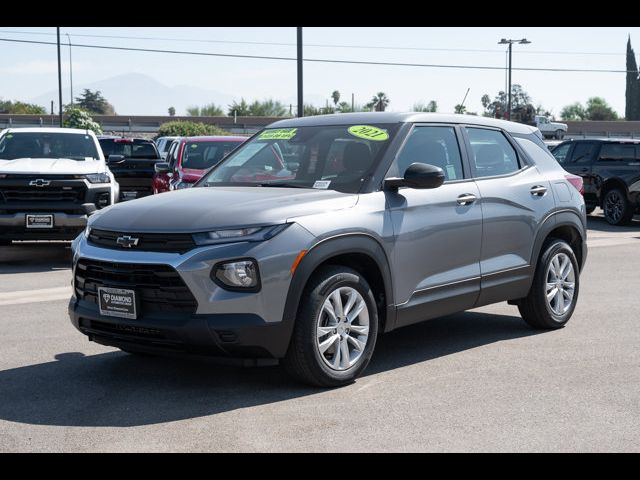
[466,127,520,177]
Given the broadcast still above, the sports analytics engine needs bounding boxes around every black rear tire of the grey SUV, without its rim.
[518,238,580,329]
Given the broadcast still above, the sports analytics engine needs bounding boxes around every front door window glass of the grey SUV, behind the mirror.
[387,126,464,181]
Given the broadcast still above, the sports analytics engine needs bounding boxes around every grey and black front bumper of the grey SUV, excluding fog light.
[69,224,313,358]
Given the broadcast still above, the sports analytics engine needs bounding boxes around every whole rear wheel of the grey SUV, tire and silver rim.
[518,239,580,329]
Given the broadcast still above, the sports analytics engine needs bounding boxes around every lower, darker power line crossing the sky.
[0,38,637,73]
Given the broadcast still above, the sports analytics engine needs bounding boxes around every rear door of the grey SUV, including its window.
[463,126,555,305]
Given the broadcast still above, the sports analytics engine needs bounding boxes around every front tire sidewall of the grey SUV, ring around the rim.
[308,272,378,383]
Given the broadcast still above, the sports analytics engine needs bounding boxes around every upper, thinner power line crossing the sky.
[0,30,626,56]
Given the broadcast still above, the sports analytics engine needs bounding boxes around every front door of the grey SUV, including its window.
[386,125,482,326]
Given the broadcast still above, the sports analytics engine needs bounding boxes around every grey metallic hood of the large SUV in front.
[89,187,358,233]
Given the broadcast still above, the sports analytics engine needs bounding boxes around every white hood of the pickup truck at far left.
[0,158,106,176]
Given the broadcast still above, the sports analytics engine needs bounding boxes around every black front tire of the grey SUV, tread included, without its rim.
[282,265,378,387]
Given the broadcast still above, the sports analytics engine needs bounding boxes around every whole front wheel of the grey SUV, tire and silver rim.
[283,266,378,387]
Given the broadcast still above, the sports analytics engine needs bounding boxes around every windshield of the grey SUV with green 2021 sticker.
[198,124,398,193]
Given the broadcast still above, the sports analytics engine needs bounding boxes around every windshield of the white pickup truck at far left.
[0,132,100,160]
